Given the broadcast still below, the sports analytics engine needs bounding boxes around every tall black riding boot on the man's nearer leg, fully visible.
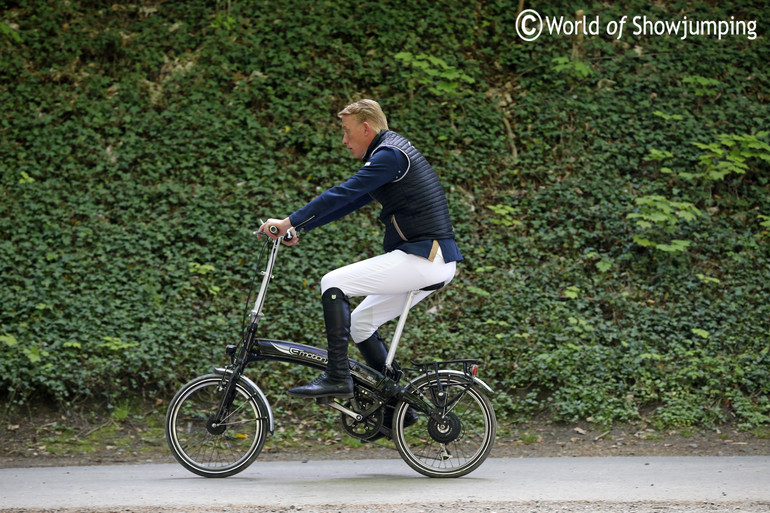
[289,287,353,397]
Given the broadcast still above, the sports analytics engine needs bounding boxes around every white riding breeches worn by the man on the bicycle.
[321,250,457,344]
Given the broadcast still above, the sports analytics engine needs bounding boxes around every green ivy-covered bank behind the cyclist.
[0,0,770,426]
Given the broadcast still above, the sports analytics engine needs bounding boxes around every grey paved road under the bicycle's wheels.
[0,457,770,509]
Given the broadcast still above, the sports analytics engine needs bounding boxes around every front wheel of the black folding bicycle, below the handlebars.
[166,374,270,477]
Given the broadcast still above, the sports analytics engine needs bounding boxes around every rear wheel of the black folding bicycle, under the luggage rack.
[393,373,497,477]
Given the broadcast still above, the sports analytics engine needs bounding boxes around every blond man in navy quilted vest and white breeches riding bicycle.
[260,100,462,404]
